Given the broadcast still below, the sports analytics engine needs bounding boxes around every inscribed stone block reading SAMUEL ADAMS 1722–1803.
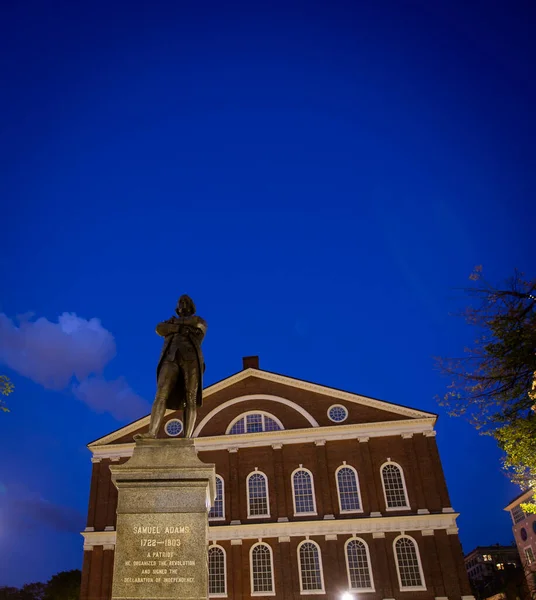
[112,513,207,600]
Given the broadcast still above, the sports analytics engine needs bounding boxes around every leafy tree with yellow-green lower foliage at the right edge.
[438,266,536,512]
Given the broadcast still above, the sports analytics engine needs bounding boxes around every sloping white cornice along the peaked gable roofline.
[89,369,437,447]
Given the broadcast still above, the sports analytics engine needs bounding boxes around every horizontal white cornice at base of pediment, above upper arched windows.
[89,418,435,458]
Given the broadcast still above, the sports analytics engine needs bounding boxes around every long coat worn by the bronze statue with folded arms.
[156,317,206,410]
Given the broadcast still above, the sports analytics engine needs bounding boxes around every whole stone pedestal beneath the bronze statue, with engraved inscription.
[110,439,216,600]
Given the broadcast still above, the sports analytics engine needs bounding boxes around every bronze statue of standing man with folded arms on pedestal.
[135,295,207,439]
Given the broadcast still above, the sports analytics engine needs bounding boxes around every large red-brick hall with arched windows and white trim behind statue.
[81,357,473,600]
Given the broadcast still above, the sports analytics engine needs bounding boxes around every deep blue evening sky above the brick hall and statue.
[0,0,536,585]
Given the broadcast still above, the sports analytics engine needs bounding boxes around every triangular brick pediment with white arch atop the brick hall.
[89,368,437,448]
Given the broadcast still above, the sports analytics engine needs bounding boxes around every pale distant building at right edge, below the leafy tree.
[504,490,536,595]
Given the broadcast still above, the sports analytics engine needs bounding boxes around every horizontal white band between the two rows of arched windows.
[82,513,459,548]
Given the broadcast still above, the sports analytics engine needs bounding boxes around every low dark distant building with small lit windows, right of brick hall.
[465,544,522,600]
